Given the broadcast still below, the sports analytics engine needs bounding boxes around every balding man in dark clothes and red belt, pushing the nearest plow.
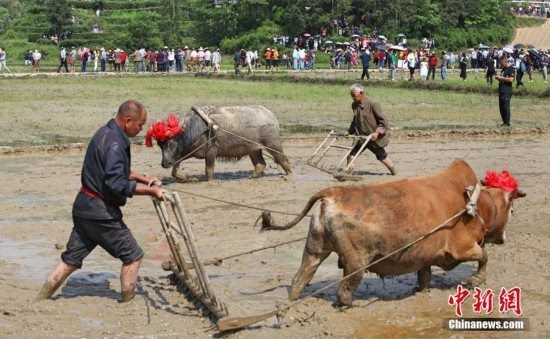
[33,100,164,303]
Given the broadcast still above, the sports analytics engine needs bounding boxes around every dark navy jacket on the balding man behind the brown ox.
[73,119,137,219]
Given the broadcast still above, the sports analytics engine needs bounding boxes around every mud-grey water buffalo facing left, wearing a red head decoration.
[147,106,291,181]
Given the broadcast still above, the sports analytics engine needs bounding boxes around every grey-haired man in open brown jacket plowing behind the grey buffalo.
[344,84,397,175]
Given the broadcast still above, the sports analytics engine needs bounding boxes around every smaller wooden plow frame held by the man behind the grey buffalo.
[307,131,371,181]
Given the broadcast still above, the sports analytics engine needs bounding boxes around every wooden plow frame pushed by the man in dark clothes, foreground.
[152,192,286,331]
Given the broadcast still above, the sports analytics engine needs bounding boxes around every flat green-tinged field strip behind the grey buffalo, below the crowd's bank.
[0,77,550,146]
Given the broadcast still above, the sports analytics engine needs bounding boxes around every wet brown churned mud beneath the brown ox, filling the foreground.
[0,135,550,338]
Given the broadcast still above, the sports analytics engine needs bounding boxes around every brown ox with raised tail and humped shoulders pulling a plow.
[262,160,524,305]
